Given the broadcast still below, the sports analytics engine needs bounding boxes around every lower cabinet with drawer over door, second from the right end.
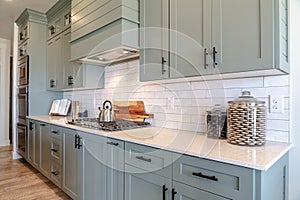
[125,142,172,200]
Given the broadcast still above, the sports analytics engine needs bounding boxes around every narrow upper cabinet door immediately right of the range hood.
[140,0,169,81]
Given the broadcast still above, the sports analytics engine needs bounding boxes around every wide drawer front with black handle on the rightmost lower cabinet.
[173,155,255,199]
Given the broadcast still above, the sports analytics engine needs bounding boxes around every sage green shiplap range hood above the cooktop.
[71,0,139,65]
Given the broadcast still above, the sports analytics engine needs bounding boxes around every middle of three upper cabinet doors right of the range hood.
[170,0,210,78]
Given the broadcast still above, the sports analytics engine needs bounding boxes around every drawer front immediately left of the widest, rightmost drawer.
[125,143,172,177]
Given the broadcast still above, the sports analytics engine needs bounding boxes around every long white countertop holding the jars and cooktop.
[28,116,292,170]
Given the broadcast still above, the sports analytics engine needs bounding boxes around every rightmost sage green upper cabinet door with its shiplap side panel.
[207,0,289,73]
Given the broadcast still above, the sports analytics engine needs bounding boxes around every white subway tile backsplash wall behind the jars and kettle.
[64,60,289,142]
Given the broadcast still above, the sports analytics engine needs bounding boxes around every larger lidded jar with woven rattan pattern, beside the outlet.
[227,91,266,146]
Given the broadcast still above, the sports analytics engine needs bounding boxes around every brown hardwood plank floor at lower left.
[0,146,70,200]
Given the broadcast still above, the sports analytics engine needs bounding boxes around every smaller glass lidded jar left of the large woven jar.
[206,104,227,139]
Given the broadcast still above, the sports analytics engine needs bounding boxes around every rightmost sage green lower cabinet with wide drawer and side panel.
[173,155,288,200]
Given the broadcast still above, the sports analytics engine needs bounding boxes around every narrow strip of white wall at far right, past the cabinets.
[289,0,300,200]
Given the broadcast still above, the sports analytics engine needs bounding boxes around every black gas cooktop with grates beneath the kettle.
[68,118,151,131]
